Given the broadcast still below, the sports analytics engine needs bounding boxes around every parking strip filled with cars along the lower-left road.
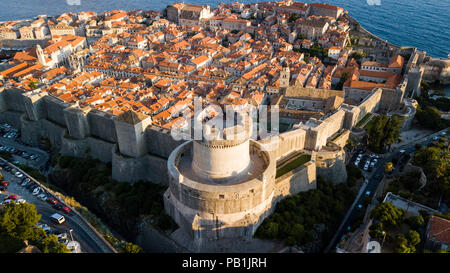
[0,160,83,253]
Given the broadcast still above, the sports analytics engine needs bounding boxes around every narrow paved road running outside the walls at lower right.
[325,128,450,252]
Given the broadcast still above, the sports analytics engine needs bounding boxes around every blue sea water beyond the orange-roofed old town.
[0,0,450,58]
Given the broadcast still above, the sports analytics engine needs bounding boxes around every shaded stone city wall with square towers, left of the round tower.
[0,86,183,184]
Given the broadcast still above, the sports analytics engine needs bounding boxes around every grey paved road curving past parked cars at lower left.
[0,159,114,253]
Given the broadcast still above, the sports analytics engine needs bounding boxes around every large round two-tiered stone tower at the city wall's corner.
[164,109,276,252]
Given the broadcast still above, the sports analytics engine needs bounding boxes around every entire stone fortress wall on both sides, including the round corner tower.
[0,81,404,251]
